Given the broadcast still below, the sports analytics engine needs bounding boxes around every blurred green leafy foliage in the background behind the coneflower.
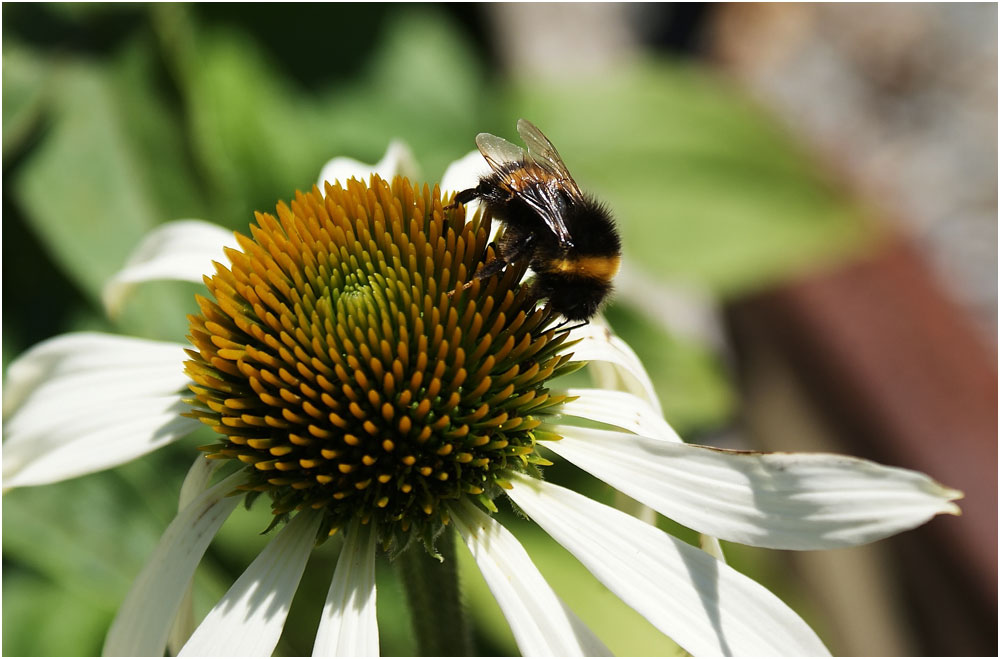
[3,4,866,655]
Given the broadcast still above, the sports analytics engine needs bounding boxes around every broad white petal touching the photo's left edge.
[3,333,201,488]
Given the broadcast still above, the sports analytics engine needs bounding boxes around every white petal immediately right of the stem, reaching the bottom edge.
[450,501,611,657]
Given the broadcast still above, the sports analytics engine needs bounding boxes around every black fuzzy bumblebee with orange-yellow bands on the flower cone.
[454,119,621,323]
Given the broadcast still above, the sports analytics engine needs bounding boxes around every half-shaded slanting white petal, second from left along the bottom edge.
[178,510,322,657]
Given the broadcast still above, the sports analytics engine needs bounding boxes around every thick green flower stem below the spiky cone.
[396,527,474,657]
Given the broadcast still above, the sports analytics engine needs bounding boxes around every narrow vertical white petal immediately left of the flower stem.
[313,520,378,657]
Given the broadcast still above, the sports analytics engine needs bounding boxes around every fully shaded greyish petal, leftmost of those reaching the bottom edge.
[103,473,246,657]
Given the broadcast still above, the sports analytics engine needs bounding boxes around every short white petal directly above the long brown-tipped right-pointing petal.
[555,389,682,442]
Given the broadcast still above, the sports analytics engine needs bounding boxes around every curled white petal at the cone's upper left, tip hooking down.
[101,220,237,317]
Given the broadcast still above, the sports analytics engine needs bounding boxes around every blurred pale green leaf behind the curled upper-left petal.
[13,62,193,338]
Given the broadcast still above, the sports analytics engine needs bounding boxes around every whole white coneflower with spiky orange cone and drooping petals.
[4,146,960,655]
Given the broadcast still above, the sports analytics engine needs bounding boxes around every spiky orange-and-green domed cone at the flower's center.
[180,177,569,540]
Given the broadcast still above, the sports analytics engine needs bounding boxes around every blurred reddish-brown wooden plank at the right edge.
[728,233,997,654]
